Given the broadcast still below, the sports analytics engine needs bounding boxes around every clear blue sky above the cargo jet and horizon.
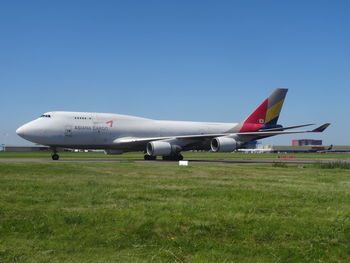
[0,0,350,145]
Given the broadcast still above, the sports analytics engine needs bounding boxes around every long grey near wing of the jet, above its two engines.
[113,123,330,144]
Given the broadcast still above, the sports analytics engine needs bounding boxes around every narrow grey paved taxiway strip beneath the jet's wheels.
[0,158,350,164]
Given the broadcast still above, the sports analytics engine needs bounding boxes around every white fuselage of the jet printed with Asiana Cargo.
[16,112,241,151]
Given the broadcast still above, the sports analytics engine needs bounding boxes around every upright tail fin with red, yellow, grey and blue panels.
[240,89,288,132]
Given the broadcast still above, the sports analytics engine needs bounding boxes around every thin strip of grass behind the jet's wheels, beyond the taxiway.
[0,152,350,160]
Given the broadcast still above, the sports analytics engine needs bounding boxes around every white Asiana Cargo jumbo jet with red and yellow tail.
[16,89,330,161]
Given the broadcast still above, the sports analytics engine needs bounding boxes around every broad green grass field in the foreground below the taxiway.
[0,162,350,263]
